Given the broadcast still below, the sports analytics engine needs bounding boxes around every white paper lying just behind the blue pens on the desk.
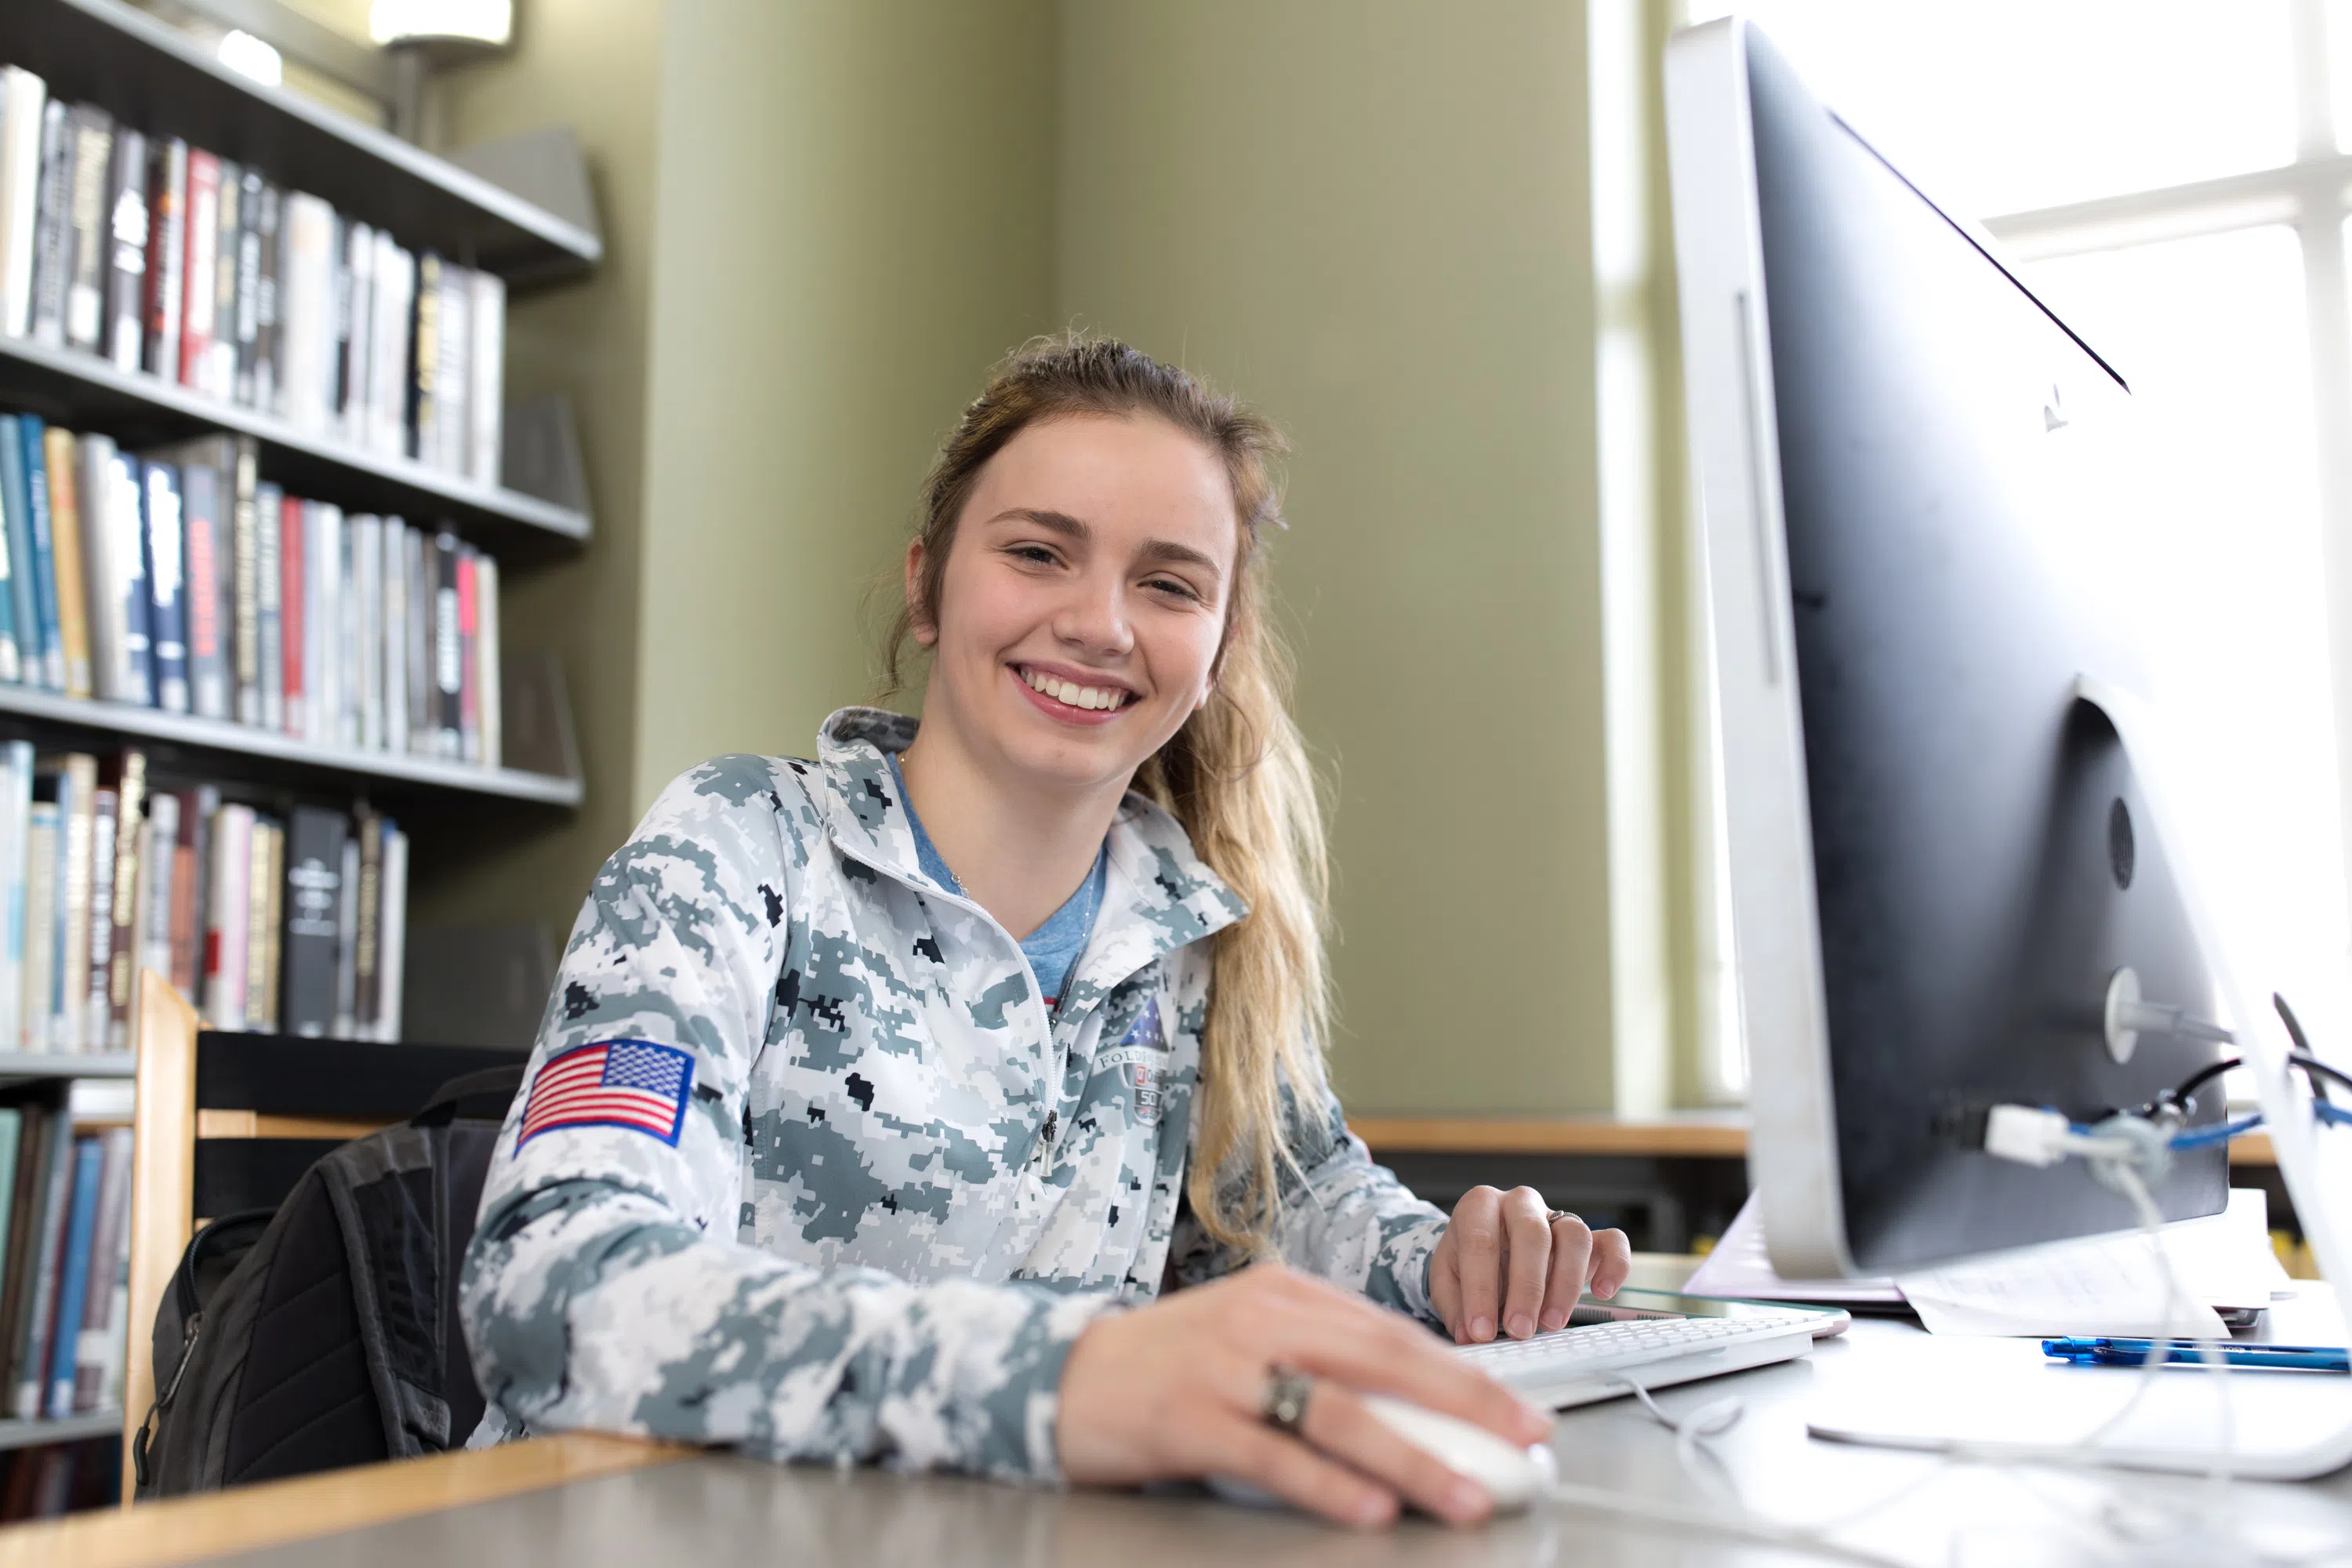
[1896,1187,2288,1338]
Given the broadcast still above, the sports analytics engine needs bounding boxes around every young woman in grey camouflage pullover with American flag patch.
[463,339,1630,1523]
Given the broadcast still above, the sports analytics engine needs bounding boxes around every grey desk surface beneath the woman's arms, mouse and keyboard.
[23,1288,2352,1568]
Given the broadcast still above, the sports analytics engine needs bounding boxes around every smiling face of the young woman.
[906,414,1240,789]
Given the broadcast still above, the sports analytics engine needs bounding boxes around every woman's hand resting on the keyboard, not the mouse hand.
[1430,1187,1632,1345]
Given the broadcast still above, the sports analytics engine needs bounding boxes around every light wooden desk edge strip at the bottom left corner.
[0,1432,701,1568]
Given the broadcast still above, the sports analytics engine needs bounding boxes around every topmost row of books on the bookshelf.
[0,66,506,485]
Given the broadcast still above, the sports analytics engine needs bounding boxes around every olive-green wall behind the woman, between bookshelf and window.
[426,0,1703,1114]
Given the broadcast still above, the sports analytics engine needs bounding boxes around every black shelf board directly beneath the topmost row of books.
[0,338,593,567]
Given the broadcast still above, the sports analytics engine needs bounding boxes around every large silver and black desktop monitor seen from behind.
[1668,19,2246,1279]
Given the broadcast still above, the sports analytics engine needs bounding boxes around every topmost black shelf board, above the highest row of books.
[0,0,604,287]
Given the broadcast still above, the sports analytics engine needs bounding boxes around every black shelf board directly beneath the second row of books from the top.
[0,687,581,806]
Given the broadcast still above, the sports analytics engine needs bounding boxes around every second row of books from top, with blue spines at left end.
[0,414,501,769]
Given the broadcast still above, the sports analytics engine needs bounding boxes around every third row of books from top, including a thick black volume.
[0,741,409,1053]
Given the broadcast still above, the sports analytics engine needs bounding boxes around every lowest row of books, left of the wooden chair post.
[0,1100,132,1420]
